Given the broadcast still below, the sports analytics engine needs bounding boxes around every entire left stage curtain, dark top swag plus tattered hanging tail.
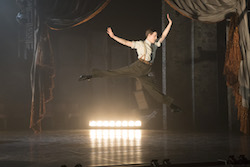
[30,0,111,133]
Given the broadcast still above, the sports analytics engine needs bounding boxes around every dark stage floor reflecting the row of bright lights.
[0,130,250,167]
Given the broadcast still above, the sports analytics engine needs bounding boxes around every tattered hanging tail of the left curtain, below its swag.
[30,24,55,133]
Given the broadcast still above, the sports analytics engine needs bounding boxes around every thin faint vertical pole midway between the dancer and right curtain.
[191,20,196,128]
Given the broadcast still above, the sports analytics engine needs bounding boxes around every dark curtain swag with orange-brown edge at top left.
[39,0,111,30]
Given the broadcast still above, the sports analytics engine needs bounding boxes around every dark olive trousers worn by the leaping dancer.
[92,60,173,106]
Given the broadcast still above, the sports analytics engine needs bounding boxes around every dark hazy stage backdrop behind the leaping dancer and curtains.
[0,0,234,130]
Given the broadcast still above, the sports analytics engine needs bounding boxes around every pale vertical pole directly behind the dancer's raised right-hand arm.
[161,0,167,130]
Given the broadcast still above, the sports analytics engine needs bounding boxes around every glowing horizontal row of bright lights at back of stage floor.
[89,120,142,127]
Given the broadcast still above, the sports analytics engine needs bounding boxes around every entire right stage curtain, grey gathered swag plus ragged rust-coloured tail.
[165,0,250,133]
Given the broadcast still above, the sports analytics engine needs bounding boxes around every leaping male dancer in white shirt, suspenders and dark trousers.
[79,14,181,112]
